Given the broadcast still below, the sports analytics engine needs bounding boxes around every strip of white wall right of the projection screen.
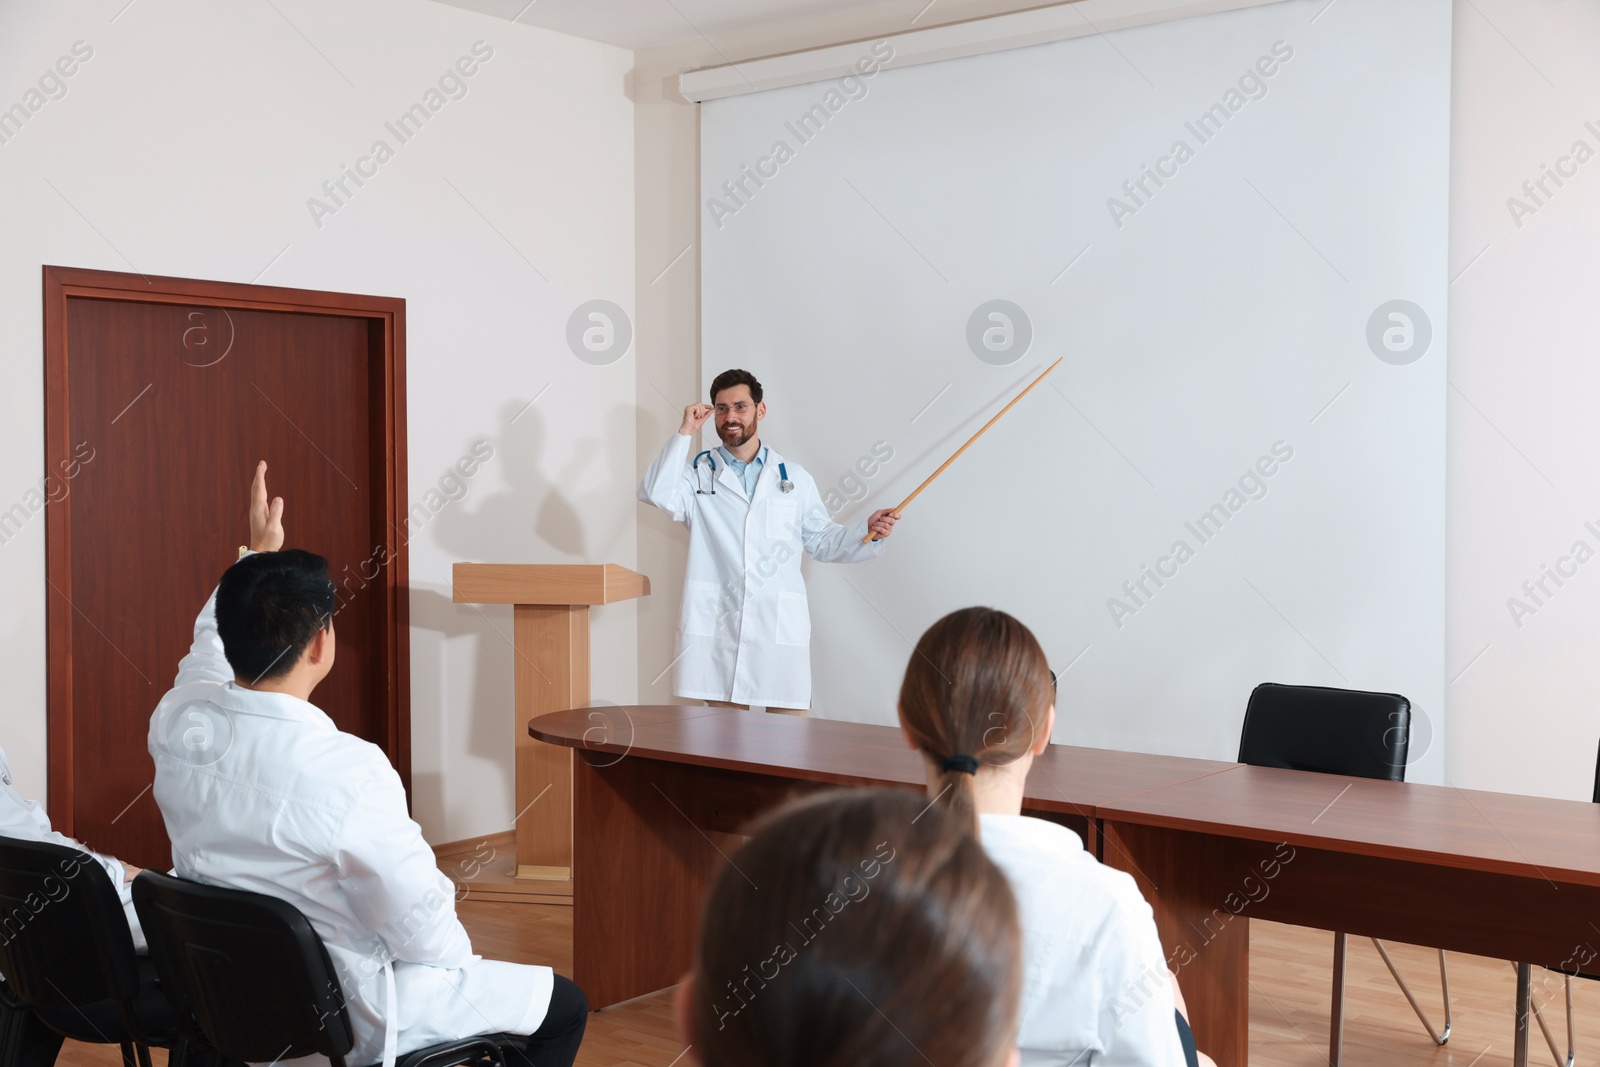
[1446,0,1600,798]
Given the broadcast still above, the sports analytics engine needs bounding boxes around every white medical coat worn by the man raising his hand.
[149,593,552,1067]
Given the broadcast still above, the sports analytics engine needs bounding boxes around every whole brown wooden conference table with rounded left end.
[528,705,1600,1067]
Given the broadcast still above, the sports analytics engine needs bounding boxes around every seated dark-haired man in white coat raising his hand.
[149,462,587,1067]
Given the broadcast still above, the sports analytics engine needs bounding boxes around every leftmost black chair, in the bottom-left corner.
[0,837,184,1067]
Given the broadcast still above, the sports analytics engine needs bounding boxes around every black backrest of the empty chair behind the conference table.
[1238,681,1411,782]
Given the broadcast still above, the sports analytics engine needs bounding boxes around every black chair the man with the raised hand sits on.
[133,870,526,1067]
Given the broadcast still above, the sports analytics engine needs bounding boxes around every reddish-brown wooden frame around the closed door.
[43,266,411,835]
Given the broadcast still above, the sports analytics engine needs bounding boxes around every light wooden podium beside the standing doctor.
[451,563,650,904]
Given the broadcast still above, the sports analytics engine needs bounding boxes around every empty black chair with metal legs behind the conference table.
[1238,681,1451,1067]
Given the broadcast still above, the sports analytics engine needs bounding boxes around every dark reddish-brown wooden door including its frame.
[45,267,410,870]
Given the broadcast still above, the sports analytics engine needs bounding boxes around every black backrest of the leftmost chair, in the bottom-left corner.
[0,837,139,1016]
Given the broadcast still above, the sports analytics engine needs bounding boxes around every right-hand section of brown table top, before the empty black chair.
[1098,765,1600,886]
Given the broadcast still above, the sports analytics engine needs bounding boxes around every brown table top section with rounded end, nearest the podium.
[528,704,1238,817]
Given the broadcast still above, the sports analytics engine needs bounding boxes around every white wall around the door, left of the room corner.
[0,0,637,841]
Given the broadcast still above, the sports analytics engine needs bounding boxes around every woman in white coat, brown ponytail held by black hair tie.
[899,608,1214,1067]
